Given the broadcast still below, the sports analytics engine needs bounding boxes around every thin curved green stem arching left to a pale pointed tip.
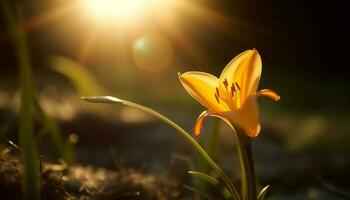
[82,96,241,200]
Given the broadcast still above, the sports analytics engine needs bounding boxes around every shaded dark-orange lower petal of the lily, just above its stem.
[224,96,260,137]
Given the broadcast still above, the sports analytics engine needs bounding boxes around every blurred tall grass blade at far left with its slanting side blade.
[1,0,78,199]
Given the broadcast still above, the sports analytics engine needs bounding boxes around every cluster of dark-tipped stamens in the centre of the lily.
[214,79,241,105]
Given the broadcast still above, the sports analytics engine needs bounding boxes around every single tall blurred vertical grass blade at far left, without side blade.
[2,0,40,200]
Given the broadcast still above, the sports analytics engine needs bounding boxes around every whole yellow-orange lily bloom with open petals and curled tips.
[179,49,280,137]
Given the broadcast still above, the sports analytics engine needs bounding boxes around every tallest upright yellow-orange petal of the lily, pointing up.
[219,49,262,108]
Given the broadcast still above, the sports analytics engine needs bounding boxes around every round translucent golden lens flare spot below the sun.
[133,33,173,72]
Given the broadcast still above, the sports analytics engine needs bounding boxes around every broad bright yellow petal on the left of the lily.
[179,71,227,111]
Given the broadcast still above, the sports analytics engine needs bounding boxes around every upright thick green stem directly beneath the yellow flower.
[236,128,257,200]
